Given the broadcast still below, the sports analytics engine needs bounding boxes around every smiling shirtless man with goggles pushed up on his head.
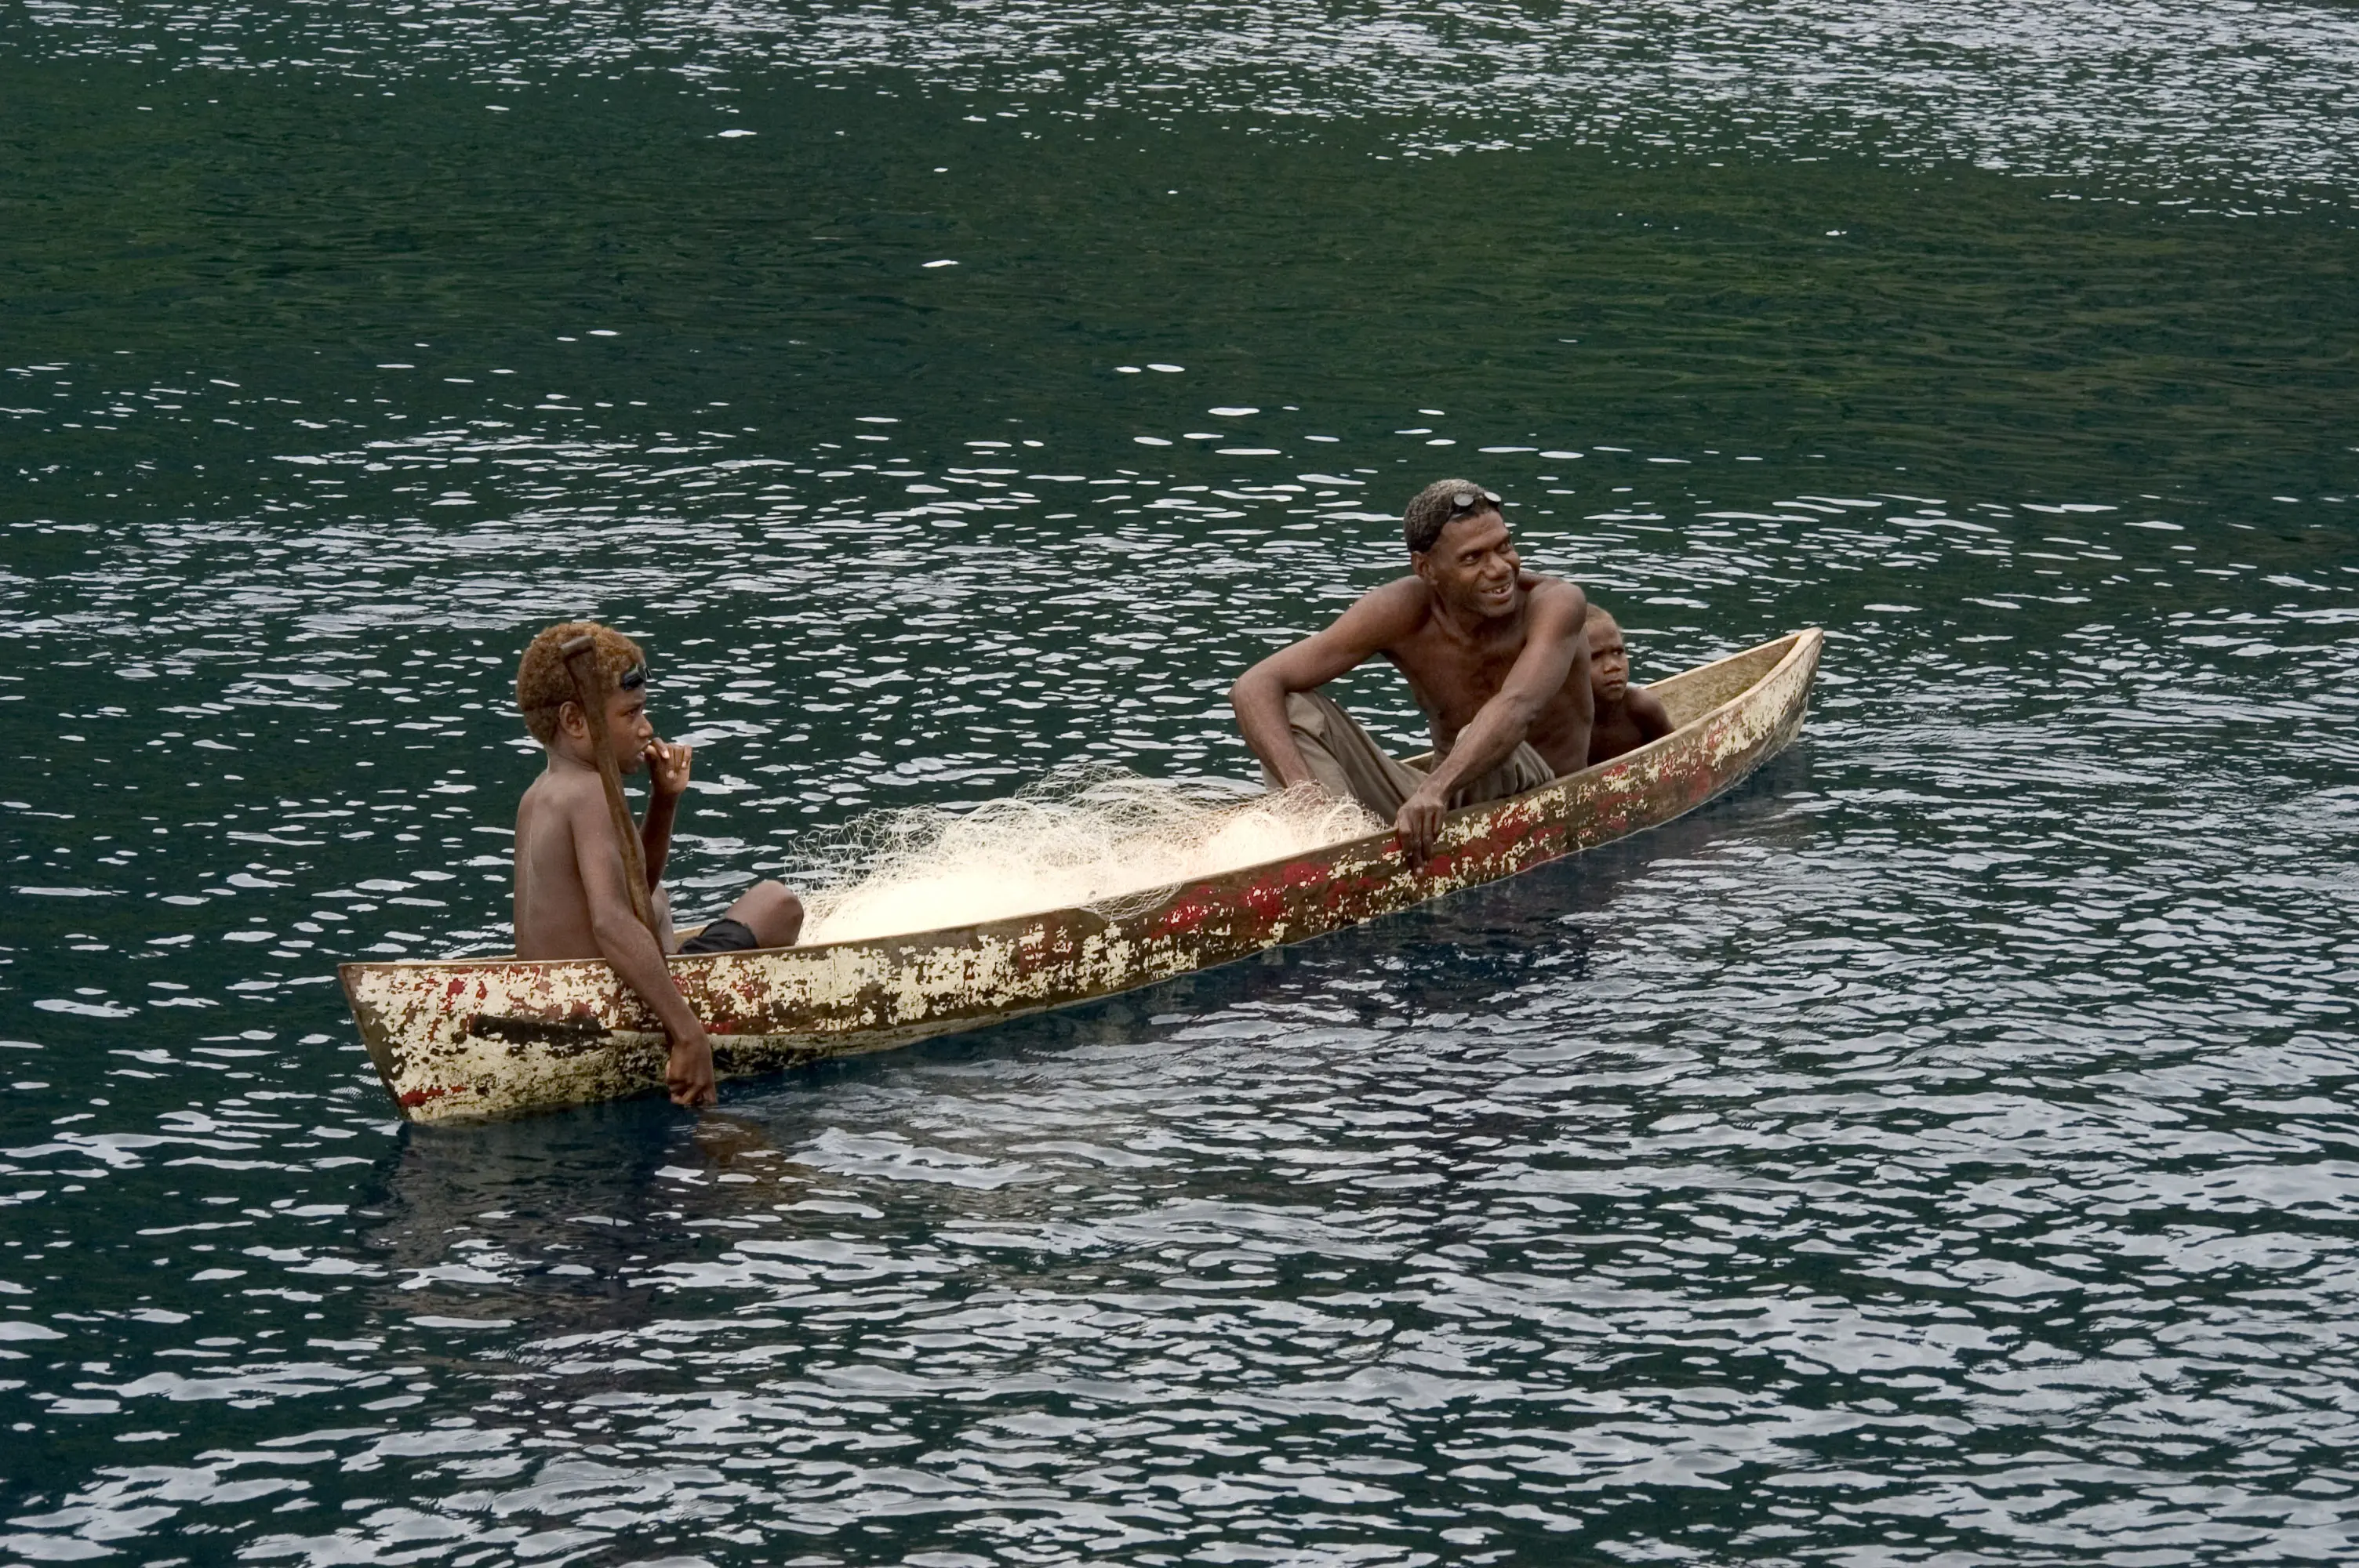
[1229,479,1594,861]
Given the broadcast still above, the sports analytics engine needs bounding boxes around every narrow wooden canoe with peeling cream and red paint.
[342,630,1821,1123]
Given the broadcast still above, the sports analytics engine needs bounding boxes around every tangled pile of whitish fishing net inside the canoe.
[798,768,1383,946]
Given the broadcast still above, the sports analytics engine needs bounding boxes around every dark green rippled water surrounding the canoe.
[0,2,2359,1568]
